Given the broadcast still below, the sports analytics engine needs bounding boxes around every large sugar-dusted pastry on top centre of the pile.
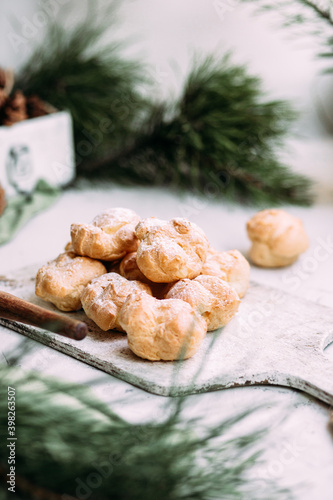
[136,217,208,283]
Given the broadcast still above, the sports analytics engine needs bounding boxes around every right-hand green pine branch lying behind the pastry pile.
[81,58,311,205]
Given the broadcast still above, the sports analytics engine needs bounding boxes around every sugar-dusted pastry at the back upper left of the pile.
[71,208,140,261]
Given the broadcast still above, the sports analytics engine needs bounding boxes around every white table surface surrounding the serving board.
[0,141,333,500]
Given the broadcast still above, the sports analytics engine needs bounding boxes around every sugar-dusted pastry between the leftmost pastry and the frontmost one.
[81,273,151,331]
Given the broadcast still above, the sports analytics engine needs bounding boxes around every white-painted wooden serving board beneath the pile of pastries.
[0,266,333,404]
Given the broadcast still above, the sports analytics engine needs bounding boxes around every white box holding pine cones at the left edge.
[0,111,75,197]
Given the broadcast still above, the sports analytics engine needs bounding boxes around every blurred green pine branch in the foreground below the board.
[0,358,290,500]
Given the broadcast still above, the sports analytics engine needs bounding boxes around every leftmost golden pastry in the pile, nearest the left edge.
[35,252,106,311]
